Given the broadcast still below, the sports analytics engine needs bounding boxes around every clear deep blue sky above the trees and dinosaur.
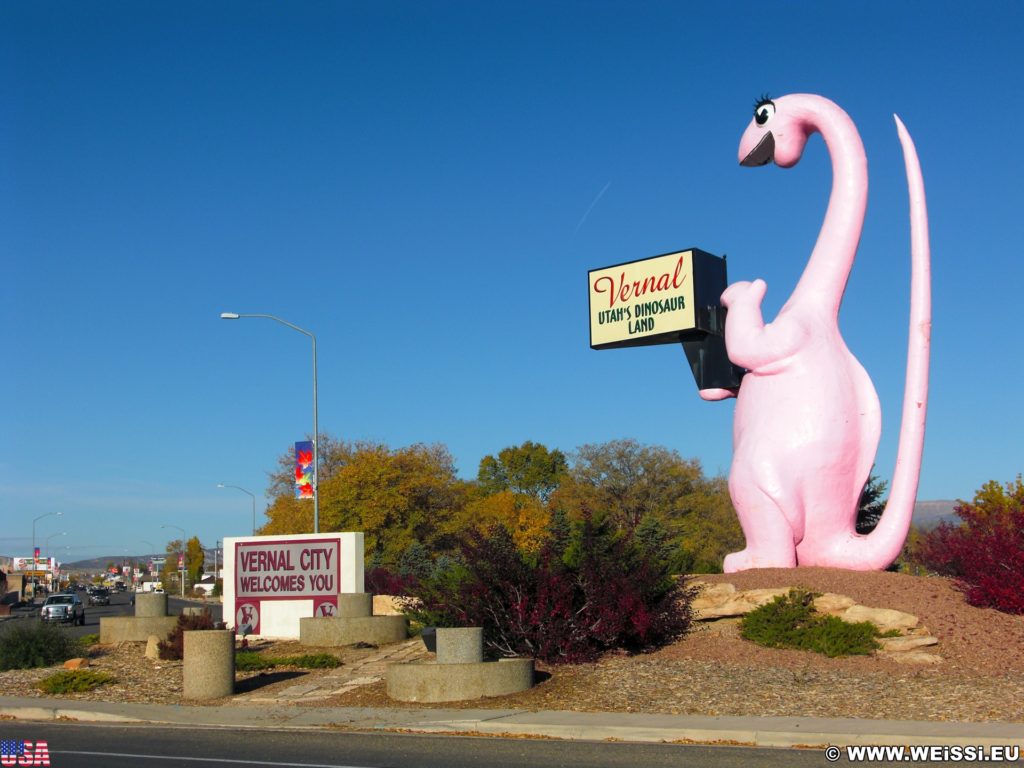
[0,0,1024,559]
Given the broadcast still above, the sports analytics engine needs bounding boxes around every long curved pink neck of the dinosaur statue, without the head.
[786,97,867,318]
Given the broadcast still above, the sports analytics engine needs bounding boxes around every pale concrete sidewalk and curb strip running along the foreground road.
[0,696,1024,746]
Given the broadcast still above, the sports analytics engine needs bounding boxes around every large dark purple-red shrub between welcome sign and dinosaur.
[407,518,692,663]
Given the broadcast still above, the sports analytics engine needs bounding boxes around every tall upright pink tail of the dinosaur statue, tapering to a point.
[858,115,932,569]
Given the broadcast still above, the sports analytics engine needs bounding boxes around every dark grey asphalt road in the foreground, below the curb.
[0,721,860,768]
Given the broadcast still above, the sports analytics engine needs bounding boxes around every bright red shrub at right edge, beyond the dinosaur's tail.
[916,476,1024,613]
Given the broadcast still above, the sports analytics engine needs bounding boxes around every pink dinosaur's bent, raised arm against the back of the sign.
[722,280,807,372]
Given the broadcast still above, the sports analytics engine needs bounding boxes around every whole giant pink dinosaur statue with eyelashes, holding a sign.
[700,94,932,572]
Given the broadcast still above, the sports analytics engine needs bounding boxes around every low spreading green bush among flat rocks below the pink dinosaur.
[739,590,882,657]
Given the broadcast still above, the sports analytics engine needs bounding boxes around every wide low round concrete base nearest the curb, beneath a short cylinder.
[385,658,534,703]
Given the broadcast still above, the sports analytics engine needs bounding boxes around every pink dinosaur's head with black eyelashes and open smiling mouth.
[739,95,816,168]
